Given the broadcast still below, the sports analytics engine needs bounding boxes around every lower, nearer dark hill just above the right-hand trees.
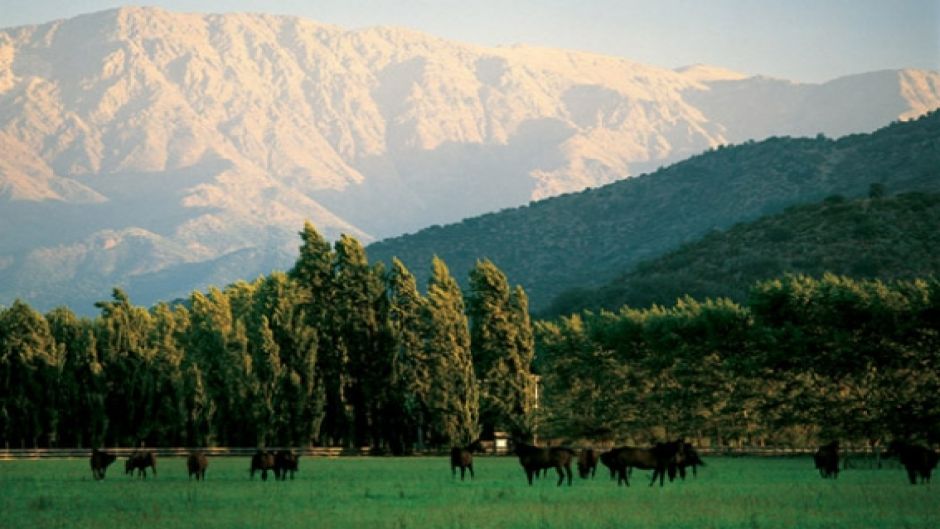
[545,190,940,315]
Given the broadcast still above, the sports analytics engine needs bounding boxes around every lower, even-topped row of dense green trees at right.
[536,275,940,446]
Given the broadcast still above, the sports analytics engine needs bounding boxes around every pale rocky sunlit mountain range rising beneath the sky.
[0,8,940,310]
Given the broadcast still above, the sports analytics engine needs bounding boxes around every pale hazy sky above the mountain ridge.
[0,0,940,82]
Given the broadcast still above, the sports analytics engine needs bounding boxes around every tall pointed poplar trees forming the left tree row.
[0,223,535,453]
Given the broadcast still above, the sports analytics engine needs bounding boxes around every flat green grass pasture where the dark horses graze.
[0,457,940,529]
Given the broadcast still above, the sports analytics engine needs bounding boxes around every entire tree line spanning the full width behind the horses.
[0,224,940,454]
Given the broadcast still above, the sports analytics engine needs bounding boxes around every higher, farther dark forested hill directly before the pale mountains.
[368,112,940,311]
